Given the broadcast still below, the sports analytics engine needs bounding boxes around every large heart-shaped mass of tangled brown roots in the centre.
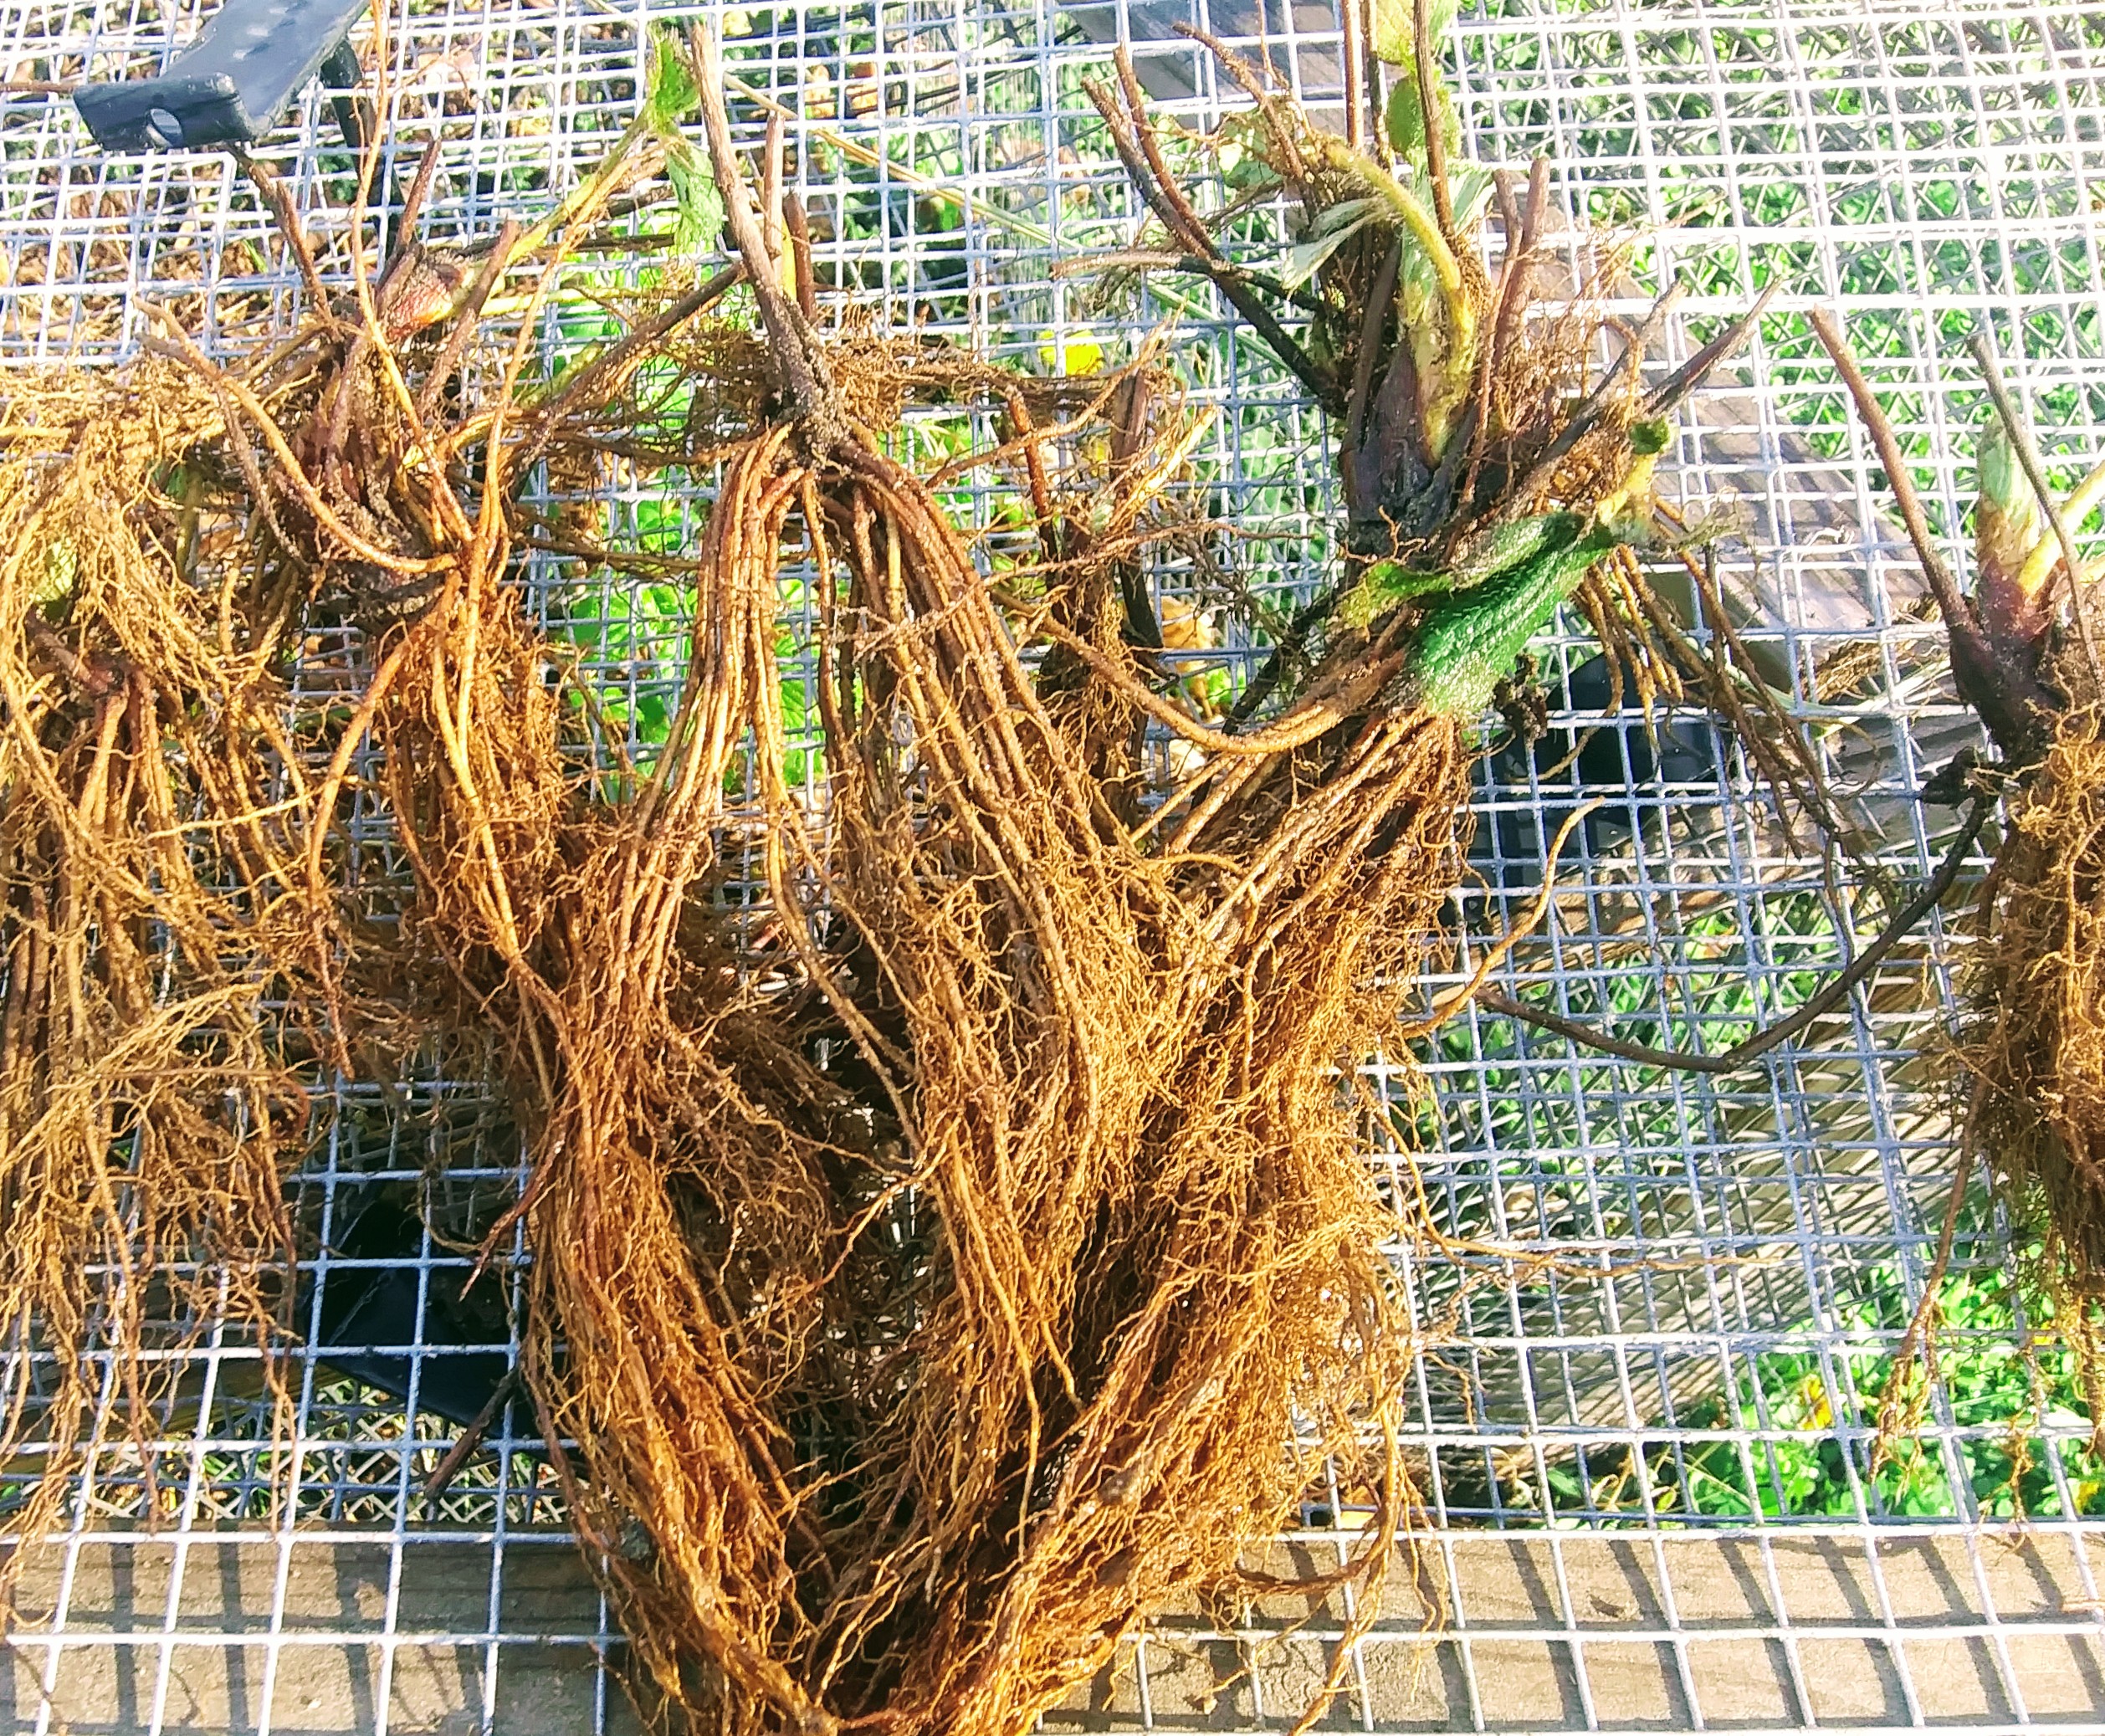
[507,429,1465,1729]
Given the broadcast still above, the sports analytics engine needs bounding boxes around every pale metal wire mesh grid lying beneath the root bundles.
[0,0,2105,1732]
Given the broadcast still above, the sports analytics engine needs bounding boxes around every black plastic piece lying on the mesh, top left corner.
[74,0,366,151]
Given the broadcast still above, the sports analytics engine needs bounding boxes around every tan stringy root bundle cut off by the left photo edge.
[0,364,307,1589]
